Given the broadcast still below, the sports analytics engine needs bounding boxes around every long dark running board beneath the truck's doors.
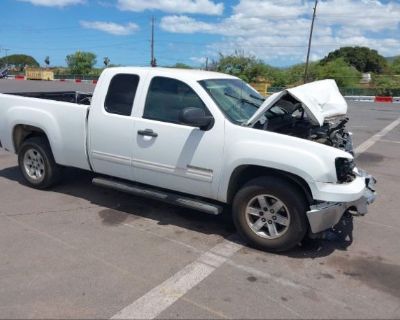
[92,178,222,215]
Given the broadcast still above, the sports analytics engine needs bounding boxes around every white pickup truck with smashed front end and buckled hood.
[0,67,375,251]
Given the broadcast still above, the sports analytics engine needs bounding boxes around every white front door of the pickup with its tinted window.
[133,76,224,198]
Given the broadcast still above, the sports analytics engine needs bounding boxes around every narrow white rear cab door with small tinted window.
[88,73,143,179]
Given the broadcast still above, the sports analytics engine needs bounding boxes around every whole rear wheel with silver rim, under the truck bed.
[18,137,61,189]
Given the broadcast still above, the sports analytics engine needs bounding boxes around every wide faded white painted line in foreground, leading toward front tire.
[111,239,243,319]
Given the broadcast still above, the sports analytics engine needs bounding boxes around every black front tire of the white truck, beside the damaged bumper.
[232,176,308,252]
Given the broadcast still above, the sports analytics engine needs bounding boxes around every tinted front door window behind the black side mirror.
[143,77,209,123]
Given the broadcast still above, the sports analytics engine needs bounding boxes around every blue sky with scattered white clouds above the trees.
[0,0,400,66]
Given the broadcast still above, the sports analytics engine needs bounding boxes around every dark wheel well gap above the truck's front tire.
[227,165,313,204]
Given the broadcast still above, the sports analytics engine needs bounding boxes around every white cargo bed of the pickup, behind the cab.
[0,91,91,169]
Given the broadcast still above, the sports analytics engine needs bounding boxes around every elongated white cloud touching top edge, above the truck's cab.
[118,0,224,15]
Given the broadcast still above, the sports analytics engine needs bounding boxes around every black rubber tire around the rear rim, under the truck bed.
[18,137,61,189]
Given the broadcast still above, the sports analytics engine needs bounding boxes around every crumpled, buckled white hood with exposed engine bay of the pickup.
[247,80,353,154]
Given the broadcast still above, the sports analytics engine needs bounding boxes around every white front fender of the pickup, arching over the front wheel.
[218,123,352,202]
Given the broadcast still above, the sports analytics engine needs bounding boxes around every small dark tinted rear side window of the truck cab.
[104,74,139,116]
